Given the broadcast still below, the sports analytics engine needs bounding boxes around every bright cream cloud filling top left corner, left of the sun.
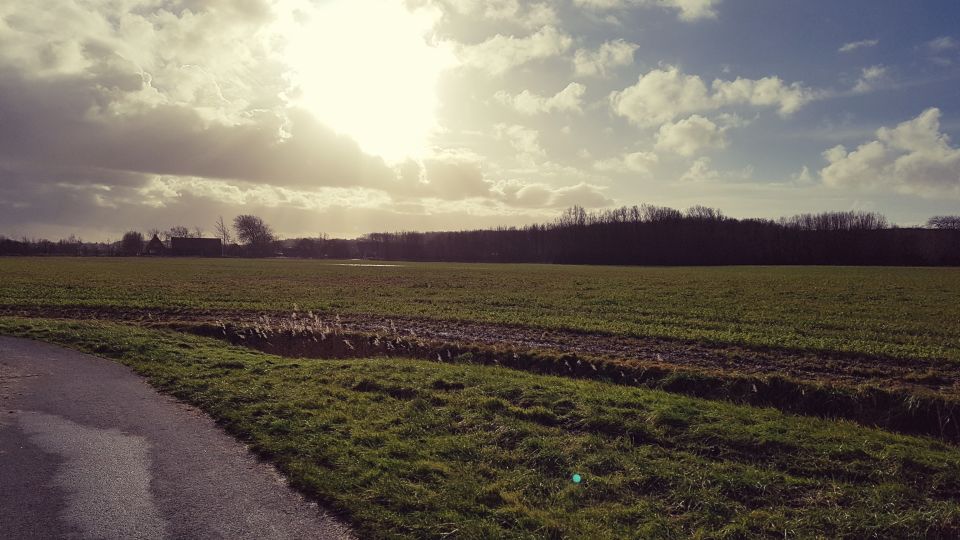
[0,0,283,123]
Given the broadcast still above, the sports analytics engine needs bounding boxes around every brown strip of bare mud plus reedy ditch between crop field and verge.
[0,307,960,442]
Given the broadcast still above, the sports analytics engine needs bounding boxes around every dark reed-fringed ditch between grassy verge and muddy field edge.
[186,323,960,444]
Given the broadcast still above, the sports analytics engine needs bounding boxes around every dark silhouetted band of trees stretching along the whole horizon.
[0,204,960,266]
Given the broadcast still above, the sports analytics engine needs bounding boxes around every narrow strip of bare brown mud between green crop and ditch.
[0,307,960,399]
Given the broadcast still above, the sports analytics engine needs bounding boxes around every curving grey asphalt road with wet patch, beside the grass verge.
[0,337,349,539]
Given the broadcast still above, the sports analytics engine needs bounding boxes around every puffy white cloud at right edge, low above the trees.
[820,108,960,198]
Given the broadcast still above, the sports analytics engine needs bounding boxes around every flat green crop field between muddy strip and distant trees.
[0,258,960,362]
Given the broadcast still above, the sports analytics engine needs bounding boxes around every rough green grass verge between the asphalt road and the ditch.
[0,318,960,538]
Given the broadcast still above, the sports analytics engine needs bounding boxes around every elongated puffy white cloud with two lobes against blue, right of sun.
[610,66,818,126]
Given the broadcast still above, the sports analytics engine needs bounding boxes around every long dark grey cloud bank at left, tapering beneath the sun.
[0,67,391,186]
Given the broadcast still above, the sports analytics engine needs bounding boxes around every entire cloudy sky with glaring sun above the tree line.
[0,0,960,240]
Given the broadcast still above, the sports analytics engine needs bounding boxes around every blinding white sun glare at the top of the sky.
[283,0,454,163]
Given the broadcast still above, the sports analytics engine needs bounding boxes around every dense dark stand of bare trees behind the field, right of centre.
[332,205,960,266]
